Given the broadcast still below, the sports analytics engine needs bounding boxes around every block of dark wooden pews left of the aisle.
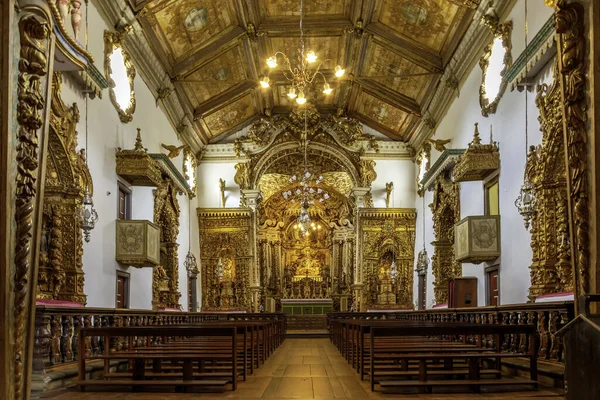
[77,319,284,391]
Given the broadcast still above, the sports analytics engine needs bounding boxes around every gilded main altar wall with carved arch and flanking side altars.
[198,105,416,314]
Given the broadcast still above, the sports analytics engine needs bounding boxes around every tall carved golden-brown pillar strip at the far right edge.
[554,0,590,295]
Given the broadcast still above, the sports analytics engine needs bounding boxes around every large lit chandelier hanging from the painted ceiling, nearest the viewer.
[260,0,346,105]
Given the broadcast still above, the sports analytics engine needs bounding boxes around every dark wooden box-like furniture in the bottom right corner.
[556,294,600,400]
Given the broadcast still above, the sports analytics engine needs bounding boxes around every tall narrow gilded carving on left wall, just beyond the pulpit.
[152,179,181,309]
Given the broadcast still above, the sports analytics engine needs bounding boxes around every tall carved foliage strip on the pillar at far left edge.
[13,9,51,398]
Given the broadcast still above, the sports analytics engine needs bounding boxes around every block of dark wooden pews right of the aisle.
[330,319,537,391]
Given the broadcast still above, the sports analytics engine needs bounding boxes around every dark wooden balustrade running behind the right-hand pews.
[327,302,574,363]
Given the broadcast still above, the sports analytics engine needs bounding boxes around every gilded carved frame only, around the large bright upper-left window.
[104,31,136,124]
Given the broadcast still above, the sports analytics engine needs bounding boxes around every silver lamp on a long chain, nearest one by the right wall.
[515,0,537,229]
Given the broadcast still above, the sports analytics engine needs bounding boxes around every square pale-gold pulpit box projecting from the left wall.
[115,220,160,267]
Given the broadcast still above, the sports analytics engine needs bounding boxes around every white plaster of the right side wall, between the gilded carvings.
[415,0,552,307]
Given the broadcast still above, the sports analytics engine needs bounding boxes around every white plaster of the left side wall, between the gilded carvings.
[56,2,199,309]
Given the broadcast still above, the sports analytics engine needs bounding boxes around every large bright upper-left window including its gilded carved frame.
[104,31,136,123]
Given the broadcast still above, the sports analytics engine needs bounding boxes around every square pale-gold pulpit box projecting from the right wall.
[454,215,500,264]
